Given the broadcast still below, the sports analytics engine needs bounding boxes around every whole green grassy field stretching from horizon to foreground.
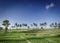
[0,29,60,43]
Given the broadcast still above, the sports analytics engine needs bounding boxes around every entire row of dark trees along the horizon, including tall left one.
[0,20,60,32]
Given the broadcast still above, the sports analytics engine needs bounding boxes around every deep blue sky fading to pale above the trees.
[0,0,60,26]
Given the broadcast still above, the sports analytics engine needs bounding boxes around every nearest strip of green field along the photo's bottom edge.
[0,38,60,43]
